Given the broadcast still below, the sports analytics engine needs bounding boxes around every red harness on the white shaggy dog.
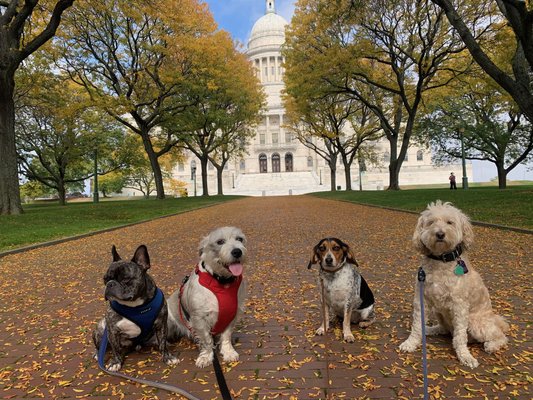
[179,266,242,335]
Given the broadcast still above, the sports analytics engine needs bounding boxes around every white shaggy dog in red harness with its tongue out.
[168,227,246,368]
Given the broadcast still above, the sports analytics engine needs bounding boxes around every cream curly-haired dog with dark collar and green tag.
[400,200,509,368]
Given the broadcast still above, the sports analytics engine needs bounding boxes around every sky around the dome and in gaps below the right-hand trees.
[204,0,533,182]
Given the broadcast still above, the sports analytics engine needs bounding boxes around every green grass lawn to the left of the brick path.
[0,196,240,251]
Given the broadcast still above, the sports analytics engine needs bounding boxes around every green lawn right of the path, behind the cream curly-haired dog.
[313,185,533,229]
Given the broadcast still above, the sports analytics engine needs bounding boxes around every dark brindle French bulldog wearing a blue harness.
[93,245,178,371]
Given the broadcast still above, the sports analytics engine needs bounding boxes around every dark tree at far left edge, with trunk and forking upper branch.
[0,0,74,214]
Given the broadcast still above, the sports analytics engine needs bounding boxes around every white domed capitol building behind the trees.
[169,0,472,196]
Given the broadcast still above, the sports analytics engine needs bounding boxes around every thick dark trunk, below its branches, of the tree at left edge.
[0,69,23,215]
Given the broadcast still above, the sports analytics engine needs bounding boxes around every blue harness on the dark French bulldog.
[111,288,166,344]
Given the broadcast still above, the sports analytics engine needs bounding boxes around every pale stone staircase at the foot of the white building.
[225,171,329,196]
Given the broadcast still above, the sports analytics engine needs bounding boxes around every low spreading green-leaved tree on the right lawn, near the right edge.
[419,79,533,189]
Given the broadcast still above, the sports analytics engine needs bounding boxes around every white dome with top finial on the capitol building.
[248,2,287,53]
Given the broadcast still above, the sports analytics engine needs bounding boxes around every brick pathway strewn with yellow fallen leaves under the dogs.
[0,196,533,399]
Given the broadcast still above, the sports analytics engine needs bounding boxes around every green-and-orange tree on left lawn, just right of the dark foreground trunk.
[16,71,127,205]
